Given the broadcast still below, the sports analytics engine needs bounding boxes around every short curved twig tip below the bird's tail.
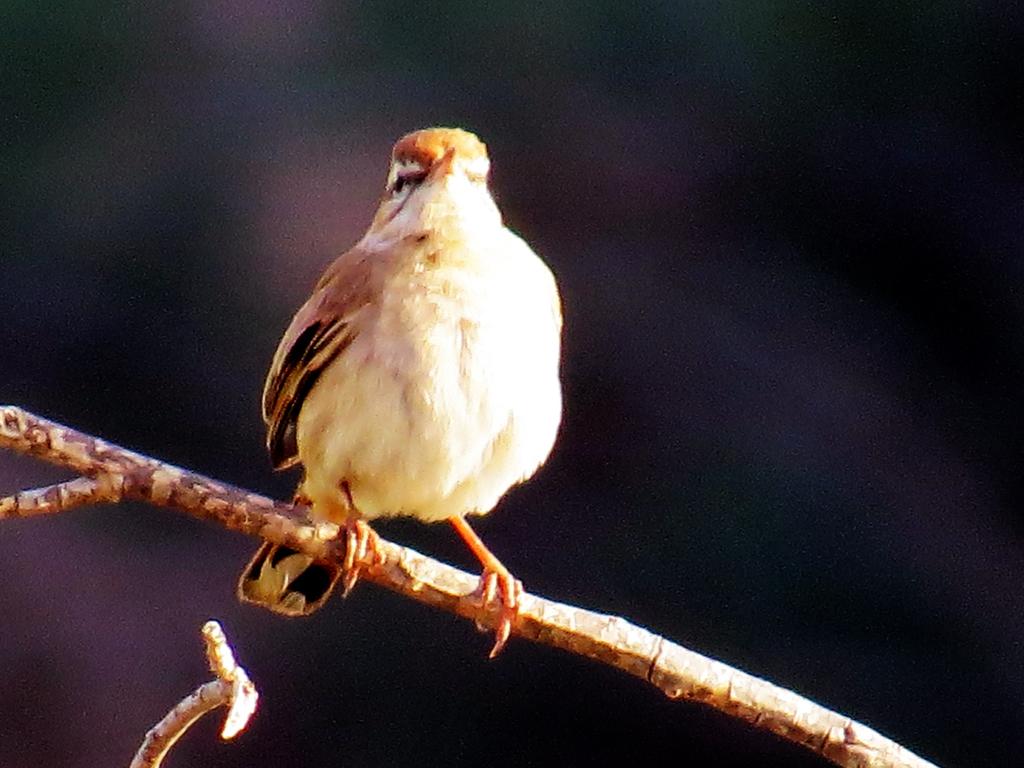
[128,622,259,768]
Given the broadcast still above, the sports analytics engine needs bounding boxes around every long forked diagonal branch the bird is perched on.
[0,406,935,768]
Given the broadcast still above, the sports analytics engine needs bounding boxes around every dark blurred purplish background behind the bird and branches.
[0,0,1024,768]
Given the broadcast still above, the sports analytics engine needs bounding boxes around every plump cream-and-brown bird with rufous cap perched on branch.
[239,128,562,656]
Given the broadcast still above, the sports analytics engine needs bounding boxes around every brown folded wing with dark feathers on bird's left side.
[263,247,374,469]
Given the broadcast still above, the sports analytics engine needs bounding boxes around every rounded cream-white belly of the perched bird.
[297,236,561,522]
